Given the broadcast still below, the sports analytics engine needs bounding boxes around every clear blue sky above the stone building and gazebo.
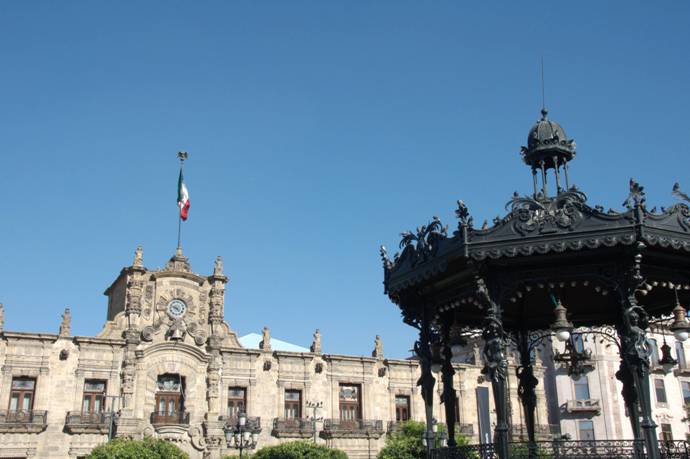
[0,0,690,357]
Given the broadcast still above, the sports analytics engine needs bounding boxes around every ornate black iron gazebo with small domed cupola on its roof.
[381,110,690,459]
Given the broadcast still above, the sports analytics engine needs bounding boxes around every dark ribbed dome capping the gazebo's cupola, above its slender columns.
[522,108,575,169]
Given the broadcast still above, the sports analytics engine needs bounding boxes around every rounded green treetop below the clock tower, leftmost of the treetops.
[87,438,189,459]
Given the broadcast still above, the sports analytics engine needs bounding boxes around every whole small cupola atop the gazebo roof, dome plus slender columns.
[520,107,575,198]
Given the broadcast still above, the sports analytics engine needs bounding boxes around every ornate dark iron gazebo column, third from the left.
[477,279,508,459]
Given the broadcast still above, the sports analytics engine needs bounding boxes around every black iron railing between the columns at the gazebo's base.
[431,440,690,459]
